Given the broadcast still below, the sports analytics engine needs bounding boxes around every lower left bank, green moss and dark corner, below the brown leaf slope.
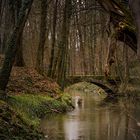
[0,94,72,140]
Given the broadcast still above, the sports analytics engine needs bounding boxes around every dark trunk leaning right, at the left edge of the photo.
[0,0,33,97]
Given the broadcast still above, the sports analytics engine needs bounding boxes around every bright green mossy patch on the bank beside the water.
[9,94,71,126]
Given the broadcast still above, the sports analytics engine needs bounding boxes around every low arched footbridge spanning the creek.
[65,75,120,95]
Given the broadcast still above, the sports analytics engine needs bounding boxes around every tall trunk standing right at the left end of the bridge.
[57,0,71,89]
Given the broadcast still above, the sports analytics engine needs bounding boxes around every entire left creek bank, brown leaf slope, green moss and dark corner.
[0,67,73,140]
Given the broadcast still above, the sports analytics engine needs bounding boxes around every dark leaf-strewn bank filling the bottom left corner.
[0,101,43,140]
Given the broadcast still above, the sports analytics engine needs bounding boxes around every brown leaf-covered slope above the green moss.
[7,67,61,97]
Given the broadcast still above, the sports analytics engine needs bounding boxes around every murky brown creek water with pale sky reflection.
[41,87,140,140]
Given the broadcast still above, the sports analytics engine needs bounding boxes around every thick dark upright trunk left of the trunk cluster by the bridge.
[36,0,47,74]
